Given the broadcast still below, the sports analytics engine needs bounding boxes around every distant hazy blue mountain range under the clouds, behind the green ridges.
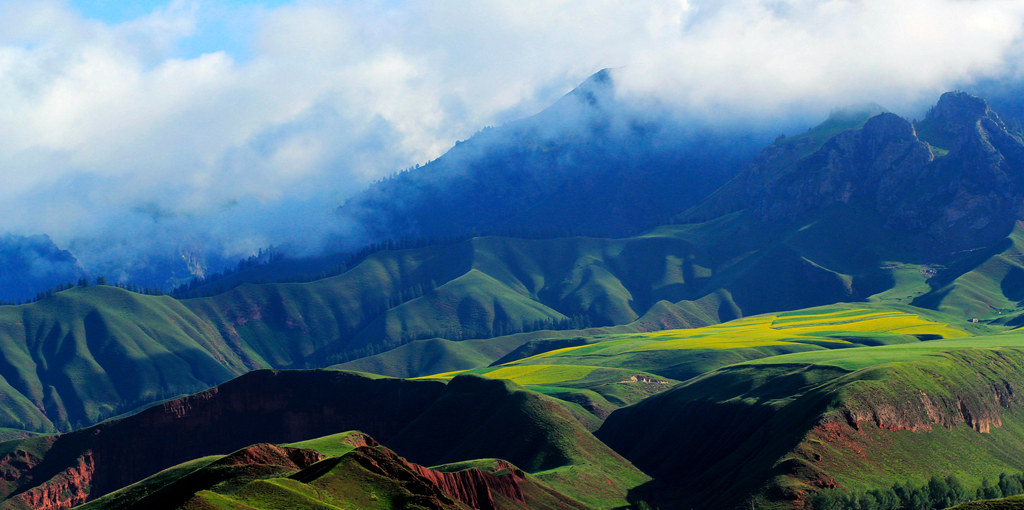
[0,70,792,300]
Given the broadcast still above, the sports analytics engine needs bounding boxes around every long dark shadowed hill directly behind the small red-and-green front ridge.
[0,371,648,508]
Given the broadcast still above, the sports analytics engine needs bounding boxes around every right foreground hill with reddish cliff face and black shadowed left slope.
[598,333,1024,508]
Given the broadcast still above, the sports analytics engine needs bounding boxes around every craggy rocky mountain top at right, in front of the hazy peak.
[688,92,1024,257]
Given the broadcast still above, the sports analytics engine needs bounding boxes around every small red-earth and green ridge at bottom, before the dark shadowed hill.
[80,432,586,510]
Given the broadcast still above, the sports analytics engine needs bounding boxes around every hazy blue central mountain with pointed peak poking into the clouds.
[338,70,776,241]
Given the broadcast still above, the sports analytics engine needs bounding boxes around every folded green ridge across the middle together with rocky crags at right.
[6,90,1024,436]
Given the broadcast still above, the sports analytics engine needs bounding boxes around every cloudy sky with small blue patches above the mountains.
[0,0,1024,278]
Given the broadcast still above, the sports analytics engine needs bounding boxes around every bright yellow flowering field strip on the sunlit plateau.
[450,303,966,380]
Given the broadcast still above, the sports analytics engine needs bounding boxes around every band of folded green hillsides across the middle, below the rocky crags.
[6,157,1024,436]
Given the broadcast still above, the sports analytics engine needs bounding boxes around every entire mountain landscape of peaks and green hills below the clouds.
[6,78,1024,509]
